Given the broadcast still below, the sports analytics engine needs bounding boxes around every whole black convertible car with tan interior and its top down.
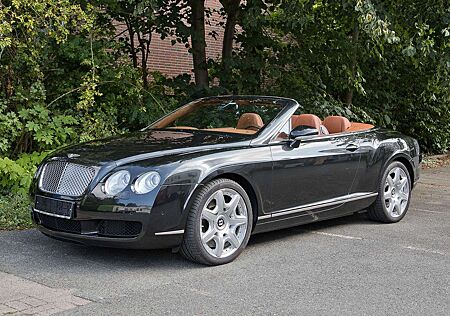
[31,96,421,265]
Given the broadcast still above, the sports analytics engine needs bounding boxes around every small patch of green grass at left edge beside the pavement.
[0,193,33,230]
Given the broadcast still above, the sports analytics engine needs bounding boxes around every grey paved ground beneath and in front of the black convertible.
[0,166,450,316]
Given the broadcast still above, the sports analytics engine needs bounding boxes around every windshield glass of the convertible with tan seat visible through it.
[148,98,283,135]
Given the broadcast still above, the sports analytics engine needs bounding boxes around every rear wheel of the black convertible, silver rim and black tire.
[367,161,412,223]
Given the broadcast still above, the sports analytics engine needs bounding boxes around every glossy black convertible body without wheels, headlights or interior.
[31,96,420,264]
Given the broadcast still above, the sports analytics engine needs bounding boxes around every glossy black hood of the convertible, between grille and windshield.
[52,130,251,166]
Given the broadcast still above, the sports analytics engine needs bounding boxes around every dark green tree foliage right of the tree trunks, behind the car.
[221,0,450,152]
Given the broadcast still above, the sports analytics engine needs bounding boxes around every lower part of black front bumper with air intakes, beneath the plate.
[31,209,183,249]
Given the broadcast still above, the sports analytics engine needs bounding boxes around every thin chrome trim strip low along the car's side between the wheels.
[258,192,378,220]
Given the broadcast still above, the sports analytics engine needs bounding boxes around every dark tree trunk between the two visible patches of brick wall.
[191,0,209,89]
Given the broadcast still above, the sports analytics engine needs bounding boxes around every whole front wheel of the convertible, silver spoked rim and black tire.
[180,179,253,265]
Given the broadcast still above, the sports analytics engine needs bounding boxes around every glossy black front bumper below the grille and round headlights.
[31,180,194,249]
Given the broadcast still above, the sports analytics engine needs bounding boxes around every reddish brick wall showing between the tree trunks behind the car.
[116,0,223,77]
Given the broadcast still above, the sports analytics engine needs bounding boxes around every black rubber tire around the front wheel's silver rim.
[191,179,253,265]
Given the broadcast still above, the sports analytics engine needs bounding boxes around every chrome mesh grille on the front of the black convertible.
[39,161,95,196]
